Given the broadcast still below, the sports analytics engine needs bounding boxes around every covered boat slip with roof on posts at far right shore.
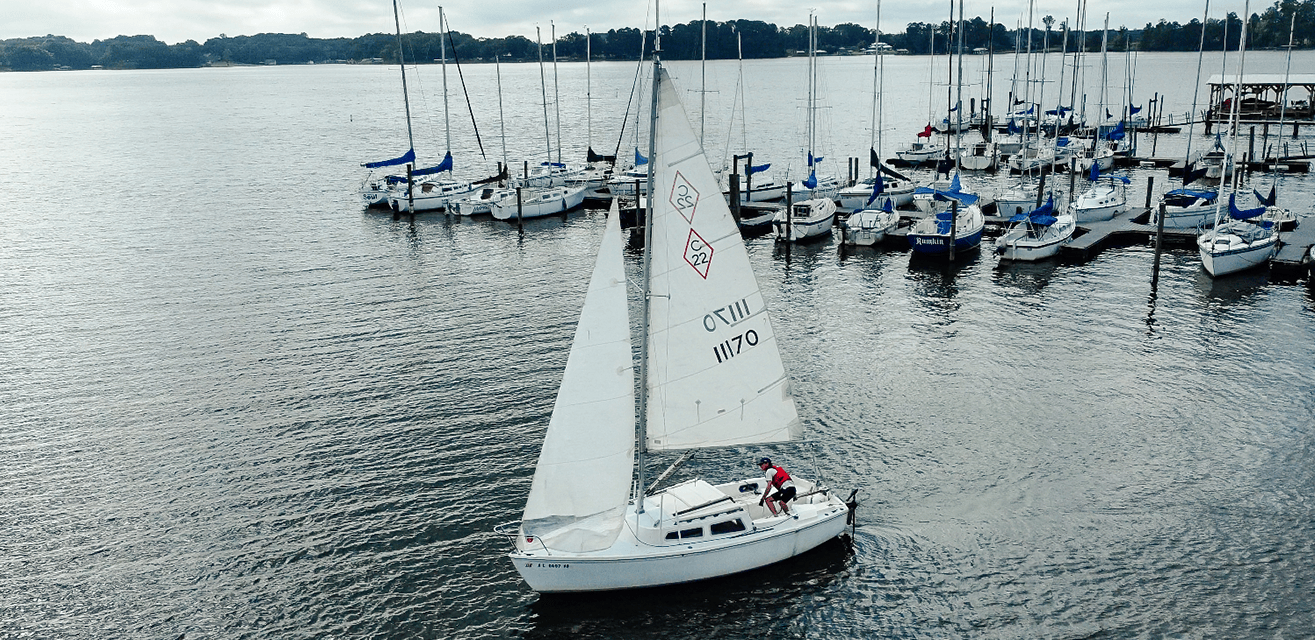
[1206,74,1315,126]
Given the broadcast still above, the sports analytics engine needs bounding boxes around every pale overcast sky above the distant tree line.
[0,0,1225,45]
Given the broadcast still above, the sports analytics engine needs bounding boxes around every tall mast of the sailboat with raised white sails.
[635,0,661,515]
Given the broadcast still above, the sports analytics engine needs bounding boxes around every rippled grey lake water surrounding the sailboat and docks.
[0,53,1315,639]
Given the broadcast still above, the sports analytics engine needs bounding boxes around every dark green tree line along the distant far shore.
[0,0,1315,71]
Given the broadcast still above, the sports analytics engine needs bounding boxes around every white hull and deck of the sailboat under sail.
[501,477,848,593]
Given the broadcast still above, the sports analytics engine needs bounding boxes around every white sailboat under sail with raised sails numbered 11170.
[497,57,849,591]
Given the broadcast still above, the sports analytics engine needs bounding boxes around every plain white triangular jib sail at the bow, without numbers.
[521,201,635,552]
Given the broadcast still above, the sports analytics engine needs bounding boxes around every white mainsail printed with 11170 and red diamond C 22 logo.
[646,70,801,449]
